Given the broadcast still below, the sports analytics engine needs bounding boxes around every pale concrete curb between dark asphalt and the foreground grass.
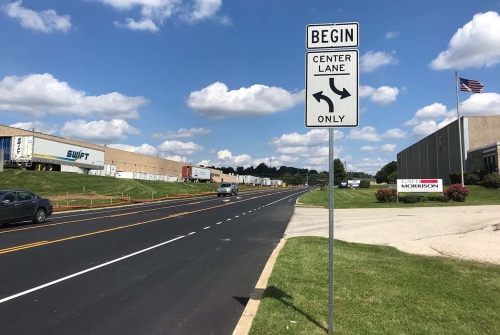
[233,237,287,335]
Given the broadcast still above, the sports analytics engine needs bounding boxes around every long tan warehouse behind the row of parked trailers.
[0,125,237,182]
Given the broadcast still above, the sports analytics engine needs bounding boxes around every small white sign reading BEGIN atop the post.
[306,22,359,49]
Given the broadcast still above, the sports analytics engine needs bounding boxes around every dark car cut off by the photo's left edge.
[0,190,53,225]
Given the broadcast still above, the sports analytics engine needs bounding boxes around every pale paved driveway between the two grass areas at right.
[285,205,500,264]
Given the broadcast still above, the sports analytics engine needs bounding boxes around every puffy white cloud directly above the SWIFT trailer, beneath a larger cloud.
[61,119,140,143]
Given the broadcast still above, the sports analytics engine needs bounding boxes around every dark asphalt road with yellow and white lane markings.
[0,188,308,335]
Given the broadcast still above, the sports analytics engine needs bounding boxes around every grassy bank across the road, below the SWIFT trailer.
[0,169,262,205]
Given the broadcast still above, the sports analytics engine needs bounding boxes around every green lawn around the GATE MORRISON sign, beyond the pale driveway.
[299,185,500,209]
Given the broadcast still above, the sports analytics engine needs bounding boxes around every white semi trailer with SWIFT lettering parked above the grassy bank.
[0,136,104,171]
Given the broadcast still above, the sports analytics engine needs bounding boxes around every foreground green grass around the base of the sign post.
[250,237,500,335]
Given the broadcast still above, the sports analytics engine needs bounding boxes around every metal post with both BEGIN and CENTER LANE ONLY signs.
[305,22,359,333]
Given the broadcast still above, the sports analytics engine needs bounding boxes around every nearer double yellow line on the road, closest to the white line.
[0,192,298,254]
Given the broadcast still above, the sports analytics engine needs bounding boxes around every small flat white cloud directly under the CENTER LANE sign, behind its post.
[268,129,344,147]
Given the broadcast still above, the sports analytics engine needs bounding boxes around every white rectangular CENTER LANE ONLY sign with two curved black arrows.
[305,50,359,127]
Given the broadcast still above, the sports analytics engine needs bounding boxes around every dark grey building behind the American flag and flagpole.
[397,116,500,185]
